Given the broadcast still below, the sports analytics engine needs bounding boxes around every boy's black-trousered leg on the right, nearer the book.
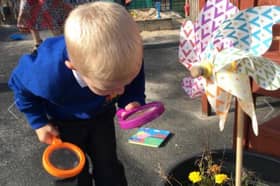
[89,108,127,186]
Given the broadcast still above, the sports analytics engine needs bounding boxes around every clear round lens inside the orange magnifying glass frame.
[49,148,80,170]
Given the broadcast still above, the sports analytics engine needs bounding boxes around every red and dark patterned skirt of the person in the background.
[17,0,72,31]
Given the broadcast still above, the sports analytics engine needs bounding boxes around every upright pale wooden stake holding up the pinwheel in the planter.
[235,103,245,186]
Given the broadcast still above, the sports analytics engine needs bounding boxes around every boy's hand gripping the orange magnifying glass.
[35,123,59,144]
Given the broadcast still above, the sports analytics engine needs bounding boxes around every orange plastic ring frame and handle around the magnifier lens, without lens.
[42,137,86,179]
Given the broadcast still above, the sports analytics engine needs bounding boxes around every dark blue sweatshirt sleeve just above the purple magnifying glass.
[118,63,146,108]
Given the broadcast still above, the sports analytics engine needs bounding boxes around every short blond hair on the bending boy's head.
[64,2,143,81]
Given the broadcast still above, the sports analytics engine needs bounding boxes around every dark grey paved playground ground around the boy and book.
[0,27,280,186]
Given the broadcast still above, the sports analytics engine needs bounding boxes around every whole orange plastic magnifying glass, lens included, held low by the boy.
[42,137,85,179]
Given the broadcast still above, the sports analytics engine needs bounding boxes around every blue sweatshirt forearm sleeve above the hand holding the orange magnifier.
[8,73,48,129]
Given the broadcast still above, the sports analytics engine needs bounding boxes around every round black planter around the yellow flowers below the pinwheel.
[162,150,280,186]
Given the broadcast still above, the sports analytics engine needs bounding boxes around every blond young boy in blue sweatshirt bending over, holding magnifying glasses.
[9,2,145,186]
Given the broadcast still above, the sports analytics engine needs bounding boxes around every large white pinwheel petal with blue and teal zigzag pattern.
[214,6,280,56]
